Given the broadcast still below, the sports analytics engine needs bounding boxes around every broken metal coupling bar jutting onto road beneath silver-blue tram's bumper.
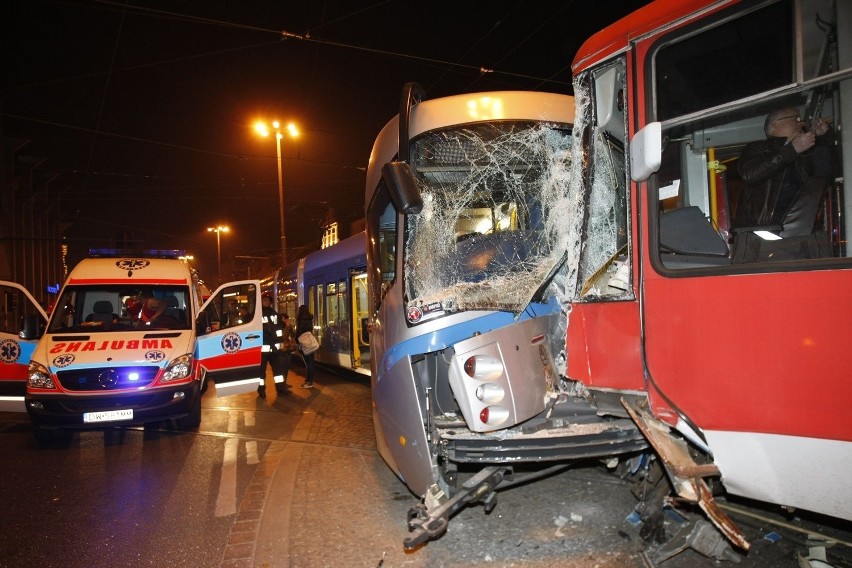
[403,466,512,550]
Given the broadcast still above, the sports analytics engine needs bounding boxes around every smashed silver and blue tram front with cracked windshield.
[366,84,646,547]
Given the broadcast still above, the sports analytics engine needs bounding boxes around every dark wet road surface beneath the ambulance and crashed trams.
[0,368,852,568]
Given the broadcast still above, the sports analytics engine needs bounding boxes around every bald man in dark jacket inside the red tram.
[736,107,834,238]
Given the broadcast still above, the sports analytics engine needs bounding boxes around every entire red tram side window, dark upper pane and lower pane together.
[649,0,852,275]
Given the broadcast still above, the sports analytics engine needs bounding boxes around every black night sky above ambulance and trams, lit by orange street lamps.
[0,0,647,282]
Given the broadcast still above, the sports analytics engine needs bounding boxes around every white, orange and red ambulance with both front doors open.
[0,250,262,442]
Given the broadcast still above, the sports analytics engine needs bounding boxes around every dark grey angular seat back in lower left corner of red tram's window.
[660,205,731,268]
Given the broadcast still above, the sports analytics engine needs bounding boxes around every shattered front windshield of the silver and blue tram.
[405,121,572,313]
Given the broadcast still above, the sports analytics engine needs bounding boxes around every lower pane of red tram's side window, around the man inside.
[656,93,846,269]
